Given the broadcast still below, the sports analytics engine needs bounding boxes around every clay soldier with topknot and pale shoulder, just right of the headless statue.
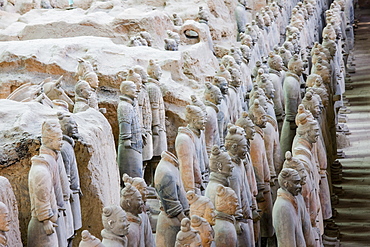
[205,146,234,205]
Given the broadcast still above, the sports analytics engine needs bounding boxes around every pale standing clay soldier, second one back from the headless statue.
[204,83,223,157]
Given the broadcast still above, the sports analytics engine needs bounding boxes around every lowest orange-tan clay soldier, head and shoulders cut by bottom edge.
[191,215,215,247]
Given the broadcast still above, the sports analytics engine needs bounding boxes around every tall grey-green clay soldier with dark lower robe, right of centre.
[280,55,303,154]
